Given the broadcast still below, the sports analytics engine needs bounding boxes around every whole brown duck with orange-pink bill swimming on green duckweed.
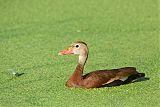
[59,41,145,88]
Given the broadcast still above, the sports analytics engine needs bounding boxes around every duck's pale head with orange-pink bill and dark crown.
[58,41,88,56]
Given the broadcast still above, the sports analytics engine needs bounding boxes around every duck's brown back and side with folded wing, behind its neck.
[83,67,144,88]
